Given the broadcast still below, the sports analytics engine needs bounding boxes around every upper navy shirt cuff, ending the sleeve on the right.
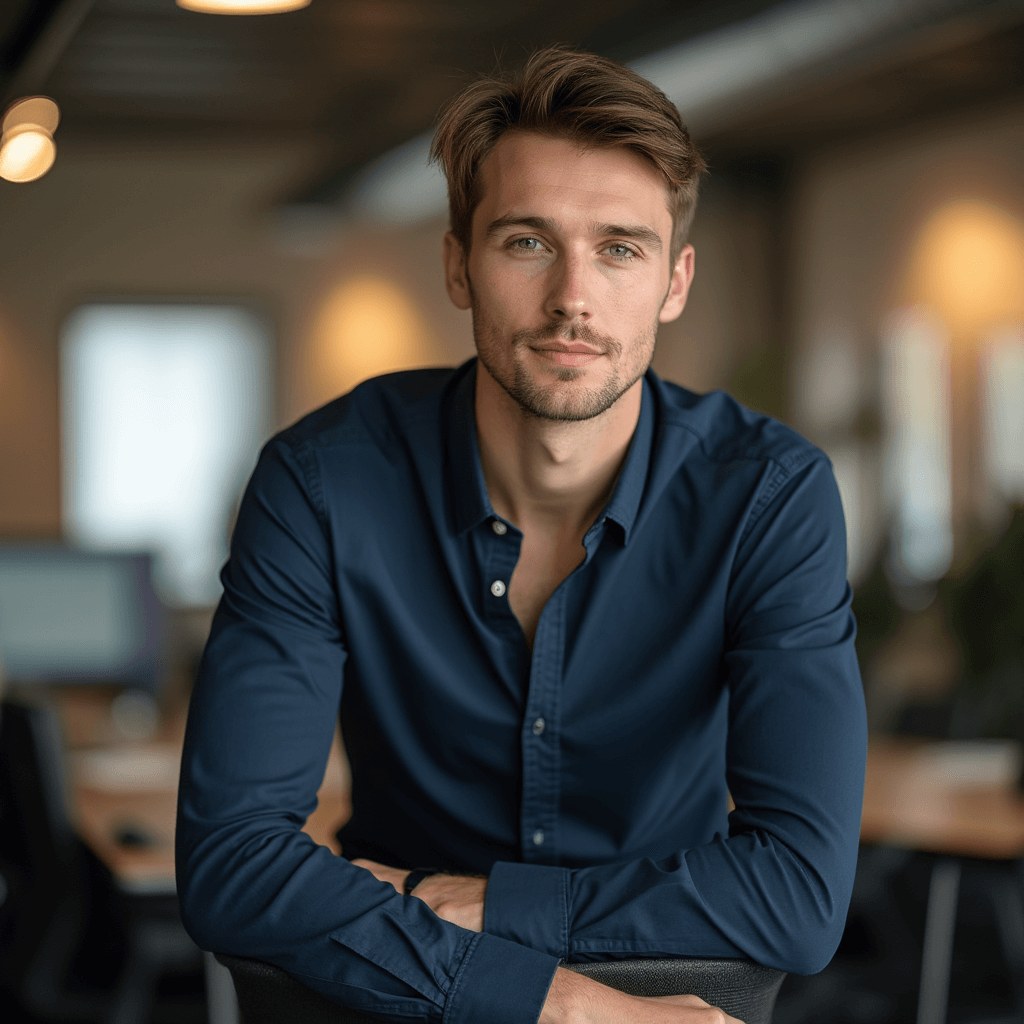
[483,860,569,959]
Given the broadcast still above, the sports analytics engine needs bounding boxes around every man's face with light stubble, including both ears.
[445,132,693,420]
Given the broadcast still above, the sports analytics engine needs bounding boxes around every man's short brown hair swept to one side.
[430,46,707,263]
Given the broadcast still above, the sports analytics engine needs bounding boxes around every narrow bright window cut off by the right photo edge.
[983,330,1024,502]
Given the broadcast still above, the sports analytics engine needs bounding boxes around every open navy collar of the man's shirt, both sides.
[447,359,654,544]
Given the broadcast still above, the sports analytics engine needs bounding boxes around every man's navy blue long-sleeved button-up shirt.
[177,361,866,1024]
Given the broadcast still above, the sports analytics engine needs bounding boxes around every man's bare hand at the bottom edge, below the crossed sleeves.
[538,967,742,1024]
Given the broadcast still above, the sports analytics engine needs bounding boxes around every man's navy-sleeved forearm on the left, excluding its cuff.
[178,787,471,1007]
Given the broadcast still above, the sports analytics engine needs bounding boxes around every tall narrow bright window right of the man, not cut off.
[883,308,953,584]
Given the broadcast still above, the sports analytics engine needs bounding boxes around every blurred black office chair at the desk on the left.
[0,700,202,1024]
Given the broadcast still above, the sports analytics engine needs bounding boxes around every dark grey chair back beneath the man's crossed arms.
[216,953,785,1024]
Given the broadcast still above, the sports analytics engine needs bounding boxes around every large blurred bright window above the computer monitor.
[61,304,270,605]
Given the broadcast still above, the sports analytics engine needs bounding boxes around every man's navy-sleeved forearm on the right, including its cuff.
[484,811,849,974]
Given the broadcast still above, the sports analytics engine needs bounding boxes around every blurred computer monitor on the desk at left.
[0,544,165,691]
